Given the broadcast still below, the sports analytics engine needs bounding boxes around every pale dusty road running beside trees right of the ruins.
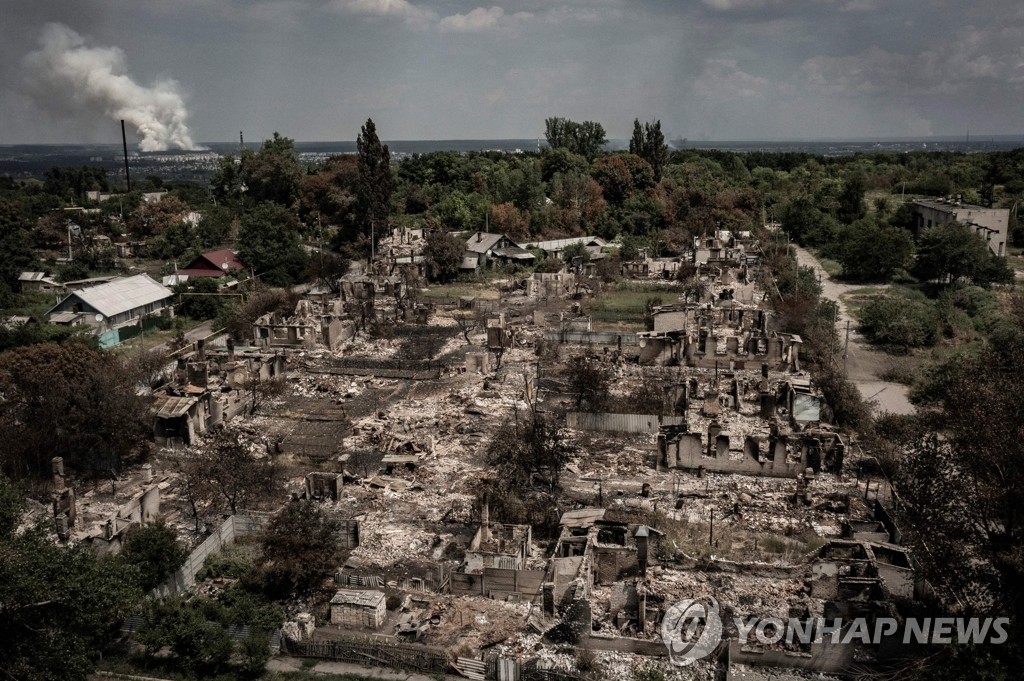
[794,246,913,414]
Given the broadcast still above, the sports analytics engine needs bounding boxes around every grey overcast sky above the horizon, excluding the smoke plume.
[0,0,1024,143]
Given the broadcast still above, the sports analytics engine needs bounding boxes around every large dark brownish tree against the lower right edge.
[884,333,1024,643]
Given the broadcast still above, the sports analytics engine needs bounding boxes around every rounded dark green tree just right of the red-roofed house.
[239,203,308,286]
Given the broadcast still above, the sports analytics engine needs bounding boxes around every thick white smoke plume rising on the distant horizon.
[25,24,197,152]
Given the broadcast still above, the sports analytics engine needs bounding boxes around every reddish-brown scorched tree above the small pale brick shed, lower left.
[261,501,344,598]
